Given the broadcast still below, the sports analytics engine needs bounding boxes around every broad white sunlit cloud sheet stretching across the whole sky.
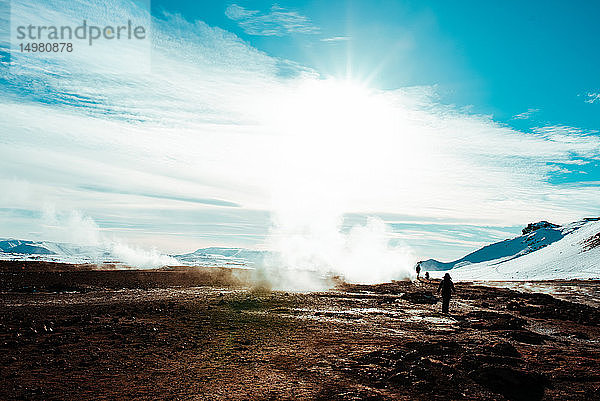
[0,0,600,271]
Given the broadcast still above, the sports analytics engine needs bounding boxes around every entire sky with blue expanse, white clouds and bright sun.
[0,0,600,260]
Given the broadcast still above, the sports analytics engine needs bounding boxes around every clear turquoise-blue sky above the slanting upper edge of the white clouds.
[152,0,600,129]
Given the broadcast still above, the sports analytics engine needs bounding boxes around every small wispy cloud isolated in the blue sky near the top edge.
[225,4,319,36]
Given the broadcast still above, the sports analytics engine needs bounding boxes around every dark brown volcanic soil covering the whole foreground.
[0,262,600,400]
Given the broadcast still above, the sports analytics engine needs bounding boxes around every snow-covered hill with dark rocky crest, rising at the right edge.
[422,218,600,280]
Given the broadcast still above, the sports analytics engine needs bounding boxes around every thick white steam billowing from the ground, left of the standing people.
[265,218,415,290]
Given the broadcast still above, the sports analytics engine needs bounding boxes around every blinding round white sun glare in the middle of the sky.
[262,79,423,216]
